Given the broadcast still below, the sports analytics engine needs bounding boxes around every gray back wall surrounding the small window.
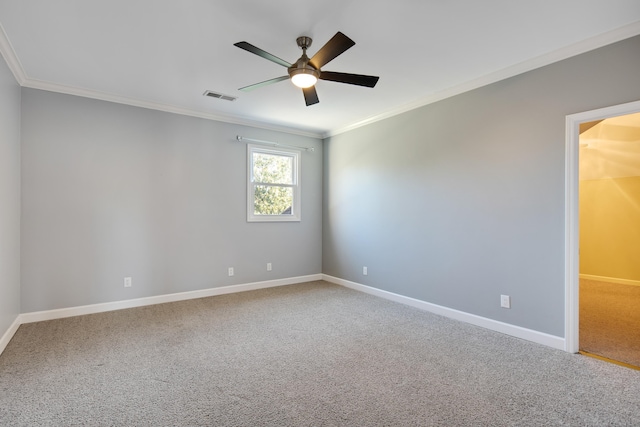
[22,89,323,312]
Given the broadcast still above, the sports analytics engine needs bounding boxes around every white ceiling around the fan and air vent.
[0,0,640,136]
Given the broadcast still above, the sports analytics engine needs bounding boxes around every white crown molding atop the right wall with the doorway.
[323,21,640,138]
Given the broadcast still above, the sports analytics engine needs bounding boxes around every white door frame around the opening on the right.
[564,101,640,353]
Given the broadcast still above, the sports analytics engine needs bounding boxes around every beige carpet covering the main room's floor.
[0,282,640,427]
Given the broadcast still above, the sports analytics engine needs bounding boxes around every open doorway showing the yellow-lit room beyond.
[578,113,640,369]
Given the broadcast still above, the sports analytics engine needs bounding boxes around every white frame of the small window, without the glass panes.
[247,144,302,222]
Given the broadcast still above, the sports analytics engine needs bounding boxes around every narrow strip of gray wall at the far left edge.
[0,52,20,337]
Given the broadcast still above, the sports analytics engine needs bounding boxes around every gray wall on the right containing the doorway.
[323,37,640,337]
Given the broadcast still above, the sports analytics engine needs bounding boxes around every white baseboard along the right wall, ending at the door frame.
[322,274,565,350]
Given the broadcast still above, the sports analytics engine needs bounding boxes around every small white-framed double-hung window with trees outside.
[247,144,300,222]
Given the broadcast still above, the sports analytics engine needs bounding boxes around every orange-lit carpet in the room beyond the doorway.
[580,279,640,367]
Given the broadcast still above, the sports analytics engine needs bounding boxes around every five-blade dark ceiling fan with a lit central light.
[234,31,379,106]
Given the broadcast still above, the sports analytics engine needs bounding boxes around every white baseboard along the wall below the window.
[18,274,322,324]
